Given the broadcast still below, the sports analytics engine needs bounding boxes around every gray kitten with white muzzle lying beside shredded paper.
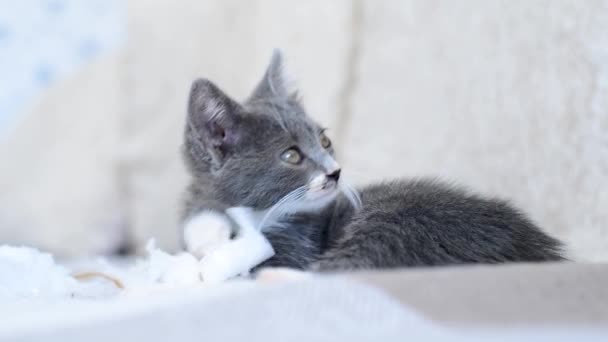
[183,53,563,271]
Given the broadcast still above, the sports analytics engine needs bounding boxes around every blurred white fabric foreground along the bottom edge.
[0,279,608,342]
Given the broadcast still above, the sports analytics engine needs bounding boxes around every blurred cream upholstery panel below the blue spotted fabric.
[0,55,125,256]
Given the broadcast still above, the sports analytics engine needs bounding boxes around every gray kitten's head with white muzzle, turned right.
[184,52,356,211]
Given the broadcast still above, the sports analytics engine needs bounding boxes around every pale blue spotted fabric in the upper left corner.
[0,0,125,132]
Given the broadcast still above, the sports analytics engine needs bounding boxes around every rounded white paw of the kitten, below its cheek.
[184,211,232,258]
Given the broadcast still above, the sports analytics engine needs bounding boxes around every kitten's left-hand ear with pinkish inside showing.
[188,79,241,166]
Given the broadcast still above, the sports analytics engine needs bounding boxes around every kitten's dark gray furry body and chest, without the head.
[264,179,561,270]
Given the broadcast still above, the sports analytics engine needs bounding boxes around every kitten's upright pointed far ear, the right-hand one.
[248,50,296,102]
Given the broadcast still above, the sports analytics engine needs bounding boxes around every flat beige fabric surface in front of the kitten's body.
[352,263,608,327]
